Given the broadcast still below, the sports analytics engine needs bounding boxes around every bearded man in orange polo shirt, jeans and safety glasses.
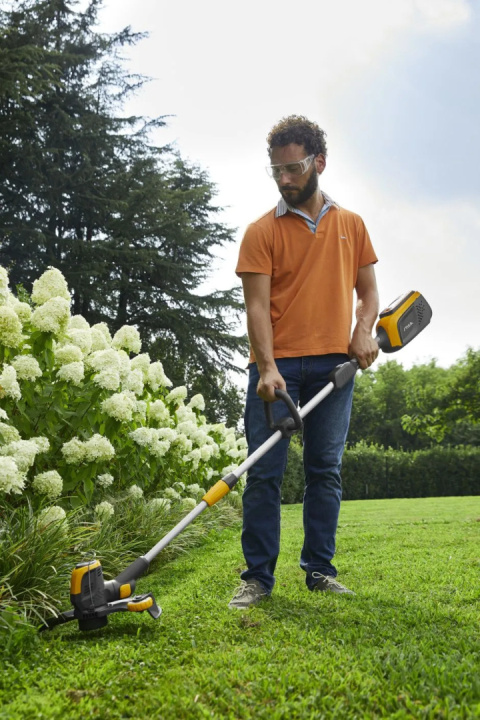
[229,115,379,609]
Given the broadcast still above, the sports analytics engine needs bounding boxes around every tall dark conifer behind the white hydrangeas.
[0,0,246,422]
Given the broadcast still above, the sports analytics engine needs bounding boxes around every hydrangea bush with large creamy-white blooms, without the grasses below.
[0,267,246,521]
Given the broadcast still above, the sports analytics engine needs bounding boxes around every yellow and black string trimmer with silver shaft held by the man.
[41,292,432,630]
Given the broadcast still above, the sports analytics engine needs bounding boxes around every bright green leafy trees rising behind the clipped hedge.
[348,348,480,451]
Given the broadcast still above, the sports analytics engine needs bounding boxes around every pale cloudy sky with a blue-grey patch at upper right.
[98,0,480,380]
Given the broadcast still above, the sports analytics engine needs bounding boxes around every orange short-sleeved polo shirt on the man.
[236,205,377,362]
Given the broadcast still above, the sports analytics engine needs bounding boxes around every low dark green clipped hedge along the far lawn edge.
[282,442,480,504]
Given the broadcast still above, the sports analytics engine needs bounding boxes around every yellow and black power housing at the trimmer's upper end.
[376,290,432,353]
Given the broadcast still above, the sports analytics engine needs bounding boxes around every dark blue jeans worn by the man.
[241,354,354,593]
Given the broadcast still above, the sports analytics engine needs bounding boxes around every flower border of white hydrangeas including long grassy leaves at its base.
[0,267,246,631]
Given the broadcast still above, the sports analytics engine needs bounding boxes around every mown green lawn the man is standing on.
[0,497,480,720]
